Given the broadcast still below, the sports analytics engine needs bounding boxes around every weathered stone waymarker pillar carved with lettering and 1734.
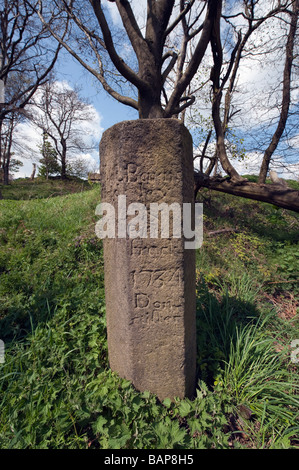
[100,119,196,400]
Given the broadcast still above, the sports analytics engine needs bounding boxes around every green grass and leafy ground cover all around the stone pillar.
[0,180,299,449]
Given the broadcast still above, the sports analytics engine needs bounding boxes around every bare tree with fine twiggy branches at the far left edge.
[0,0,67,187]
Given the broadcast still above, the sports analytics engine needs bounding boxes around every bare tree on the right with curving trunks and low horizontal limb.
[195,0,299,211]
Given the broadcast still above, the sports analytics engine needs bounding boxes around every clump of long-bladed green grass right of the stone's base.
[198,283,299,448]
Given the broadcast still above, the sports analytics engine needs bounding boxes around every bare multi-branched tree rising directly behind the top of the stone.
[35,0,219,119]
